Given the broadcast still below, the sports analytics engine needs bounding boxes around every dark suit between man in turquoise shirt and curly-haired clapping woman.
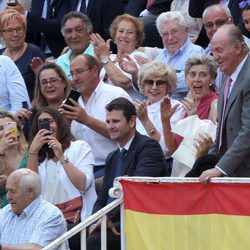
[71,0,123,40]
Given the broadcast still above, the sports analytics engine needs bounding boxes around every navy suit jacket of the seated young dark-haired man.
[93,132,167,221]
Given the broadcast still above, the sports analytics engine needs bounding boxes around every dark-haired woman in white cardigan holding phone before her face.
[27,107,96,220]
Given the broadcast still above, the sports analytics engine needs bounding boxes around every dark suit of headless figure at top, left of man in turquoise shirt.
[26,0,71,57]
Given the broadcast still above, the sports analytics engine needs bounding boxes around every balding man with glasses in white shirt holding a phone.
[59,54,130,181]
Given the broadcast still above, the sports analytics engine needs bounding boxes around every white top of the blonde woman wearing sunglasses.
[136,98,185,158]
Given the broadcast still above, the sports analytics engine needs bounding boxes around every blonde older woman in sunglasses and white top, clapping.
[135,61,184,166]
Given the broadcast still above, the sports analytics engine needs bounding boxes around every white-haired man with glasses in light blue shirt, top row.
[155,11,203,100]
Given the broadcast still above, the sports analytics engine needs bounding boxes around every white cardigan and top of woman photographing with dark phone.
[38,140,97,220]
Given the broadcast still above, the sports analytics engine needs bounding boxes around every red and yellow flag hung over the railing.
[120,180,250,250]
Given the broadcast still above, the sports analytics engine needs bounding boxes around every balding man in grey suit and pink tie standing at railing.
[200,25,250,183]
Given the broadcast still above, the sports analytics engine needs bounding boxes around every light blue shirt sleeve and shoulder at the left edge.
[0,55,30,114]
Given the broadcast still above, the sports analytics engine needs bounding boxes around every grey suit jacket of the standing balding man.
[209,56,250,177]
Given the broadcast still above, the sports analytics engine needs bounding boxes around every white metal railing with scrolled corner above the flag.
[43,177,250,250]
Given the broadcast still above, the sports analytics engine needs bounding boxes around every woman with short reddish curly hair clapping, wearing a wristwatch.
[91,14,146,99]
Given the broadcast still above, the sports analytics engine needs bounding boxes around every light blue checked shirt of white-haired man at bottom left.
[0,196,67,247]
